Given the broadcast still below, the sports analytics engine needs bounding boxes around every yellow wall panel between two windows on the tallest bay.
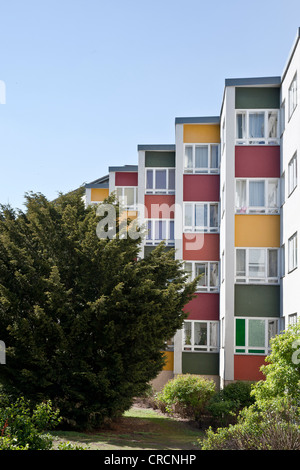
[235,214,280,247]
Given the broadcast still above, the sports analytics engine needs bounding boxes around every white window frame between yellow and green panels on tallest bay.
[234,247,280,285]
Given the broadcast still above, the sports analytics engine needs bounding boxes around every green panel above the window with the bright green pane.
[234,284,280,317]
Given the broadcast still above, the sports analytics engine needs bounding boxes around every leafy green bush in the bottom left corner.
[0,397,60,450]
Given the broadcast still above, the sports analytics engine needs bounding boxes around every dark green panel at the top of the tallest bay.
[235,87,280,109]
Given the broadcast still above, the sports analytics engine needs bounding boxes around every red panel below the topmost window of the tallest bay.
[235,145,280,178]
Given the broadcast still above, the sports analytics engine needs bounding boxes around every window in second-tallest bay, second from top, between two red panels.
[183,202,219,233]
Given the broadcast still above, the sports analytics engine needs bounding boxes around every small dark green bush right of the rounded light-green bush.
[207,382,255,426]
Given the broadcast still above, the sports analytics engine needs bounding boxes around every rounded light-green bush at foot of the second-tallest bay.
[157,374,215,420]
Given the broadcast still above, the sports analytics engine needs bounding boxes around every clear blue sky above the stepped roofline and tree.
[0,0,300,208]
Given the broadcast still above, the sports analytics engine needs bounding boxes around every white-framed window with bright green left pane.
[235,318,279,355]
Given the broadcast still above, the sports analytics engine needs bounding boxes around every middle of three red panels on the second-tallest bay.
[182,233,220,261]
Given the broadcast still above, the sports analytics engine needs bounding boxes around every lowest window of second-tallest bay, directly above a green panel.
[182,320,219,352]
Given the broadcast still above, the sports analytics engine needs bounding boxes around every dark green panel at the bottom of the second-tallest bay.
[182,352,219,375]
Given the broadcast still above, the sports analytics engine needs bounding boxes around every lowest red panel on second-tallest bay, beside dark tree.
[184,293,219,321]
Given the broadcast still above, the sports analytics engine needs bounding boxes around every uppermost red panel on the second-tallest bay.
[183,175,220,202]
